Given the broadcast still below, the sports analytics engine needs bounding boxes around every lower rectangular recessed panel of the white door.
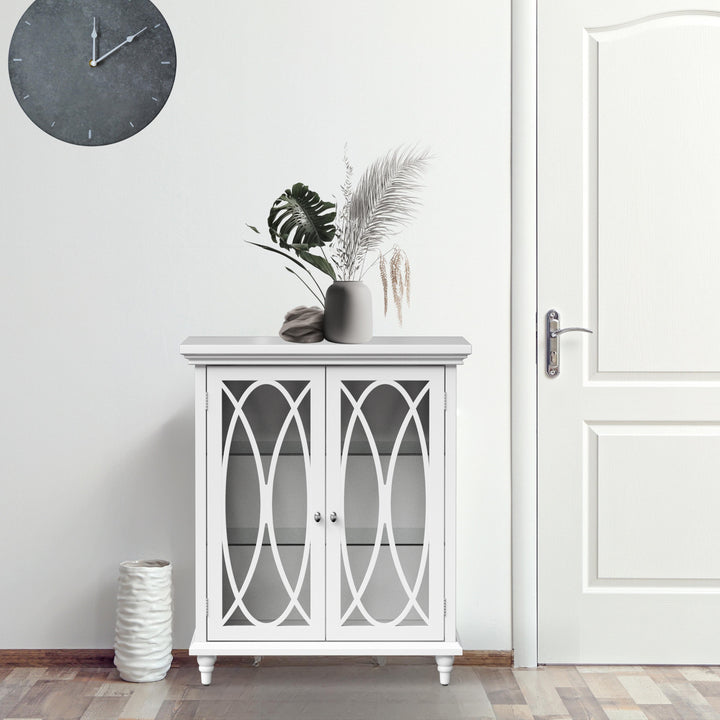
[583,420,720,594]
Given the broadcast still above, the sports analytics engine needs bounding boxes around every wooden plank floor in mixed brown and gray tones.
[0,661,720,720]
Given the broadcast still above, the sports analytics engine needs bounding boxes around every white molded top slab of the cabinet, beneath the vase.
[180,337,472,365]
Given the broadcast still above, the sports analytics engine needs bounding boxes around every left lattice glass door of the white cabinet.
[207,367,325,640]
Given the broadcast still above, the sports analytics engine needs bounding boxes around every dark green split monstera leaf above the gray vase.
[268,183,336,253]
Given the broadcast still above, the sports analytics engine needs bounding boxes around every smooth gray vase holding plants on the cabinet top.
[324,280,372,343]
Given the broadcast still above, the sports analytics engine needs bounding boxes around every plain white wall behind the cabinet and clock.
[0,0,511,650]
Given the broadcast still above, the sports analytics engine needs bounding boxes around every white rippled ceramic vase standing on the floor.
[115,560,173,682]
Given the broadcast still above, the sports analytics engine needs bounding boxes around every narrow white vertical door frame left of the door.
[511,0,542,667]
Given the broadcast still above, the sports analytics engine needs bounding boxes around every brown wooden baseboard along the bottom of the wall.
[0,649,513,668]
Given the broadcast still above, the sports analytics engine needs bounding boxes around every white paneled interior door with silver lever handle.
[538,0,720,663]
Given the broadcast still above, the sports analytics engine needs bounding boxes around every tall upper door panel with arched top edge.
[583,11,720,380]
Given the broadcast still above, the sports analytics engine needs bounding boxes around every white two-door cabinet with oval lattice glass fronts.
[182,337,470,685]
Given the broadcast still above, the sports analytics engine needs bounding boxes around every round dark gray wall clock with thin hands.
[8,0,176,145]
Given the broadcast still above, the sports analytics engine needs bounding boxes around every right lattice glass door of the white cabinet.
[326,367,445,640]
